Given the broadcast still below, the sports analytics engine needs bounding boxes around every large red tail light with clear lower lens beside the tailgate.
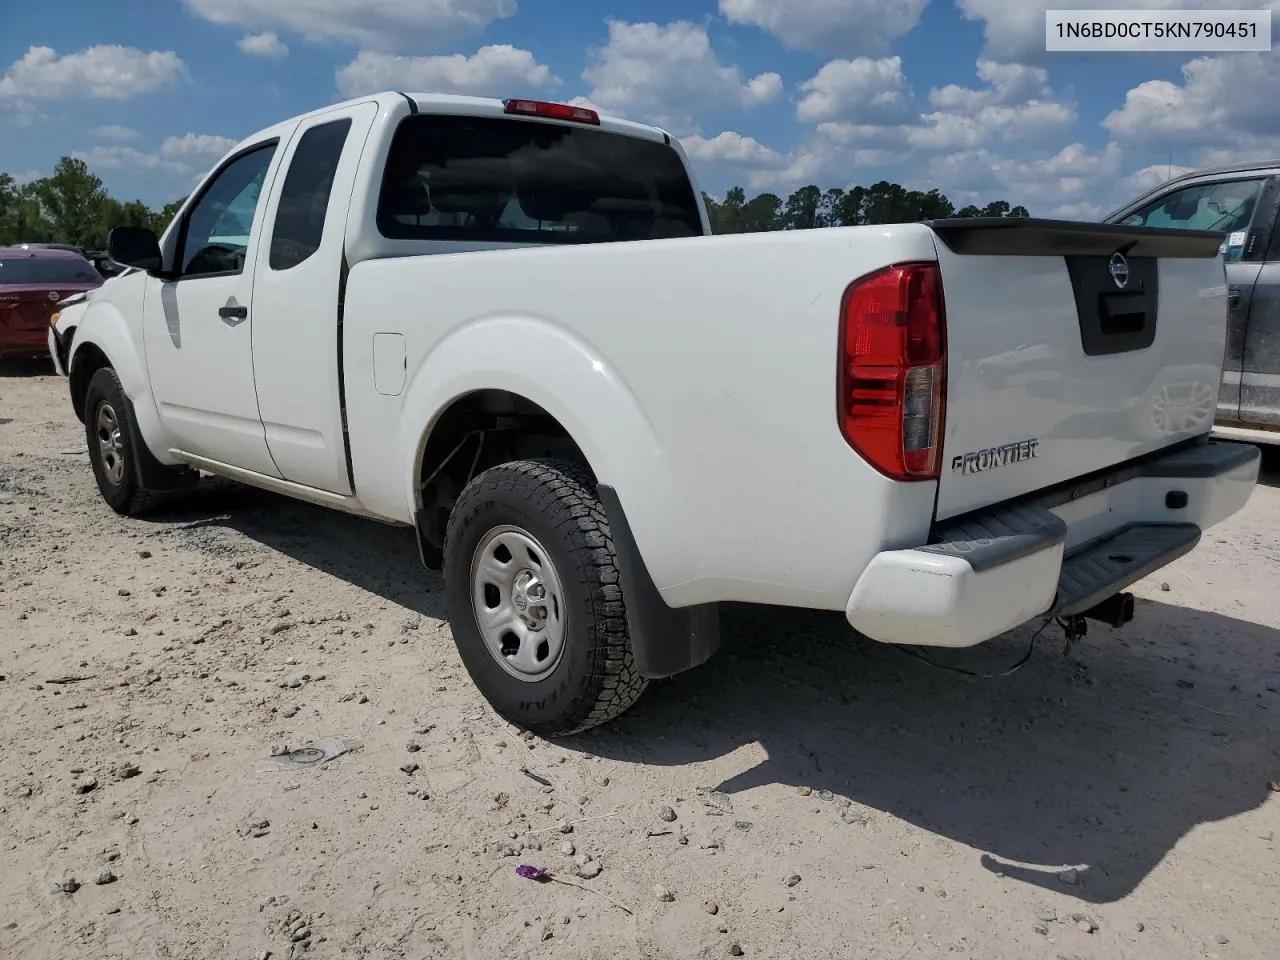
[838,262,946,480]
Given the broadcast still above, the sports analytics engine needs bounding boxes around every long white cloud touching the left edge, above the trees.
[0,45,186,101]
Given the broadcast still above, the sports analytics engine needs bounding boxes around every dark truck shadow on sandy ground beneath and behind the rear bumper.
[573,600,1280,904]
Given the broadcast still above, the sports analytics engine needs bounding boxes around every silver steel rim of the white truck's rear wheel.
[471,526,564,684]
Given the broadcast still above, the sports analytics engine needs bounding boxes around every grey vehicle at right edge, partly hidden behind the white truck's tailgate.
[1106,160,1280,444]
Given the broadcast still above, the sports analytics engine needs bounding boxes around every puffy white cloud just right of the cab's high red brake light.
[582,20,782,134]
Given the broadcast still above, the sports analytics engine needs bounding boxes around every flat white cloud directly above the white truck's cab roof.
[334,45,561,97]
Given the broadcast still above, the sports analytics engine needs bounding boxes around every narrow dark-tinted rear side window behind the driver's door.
[269,118,351,270]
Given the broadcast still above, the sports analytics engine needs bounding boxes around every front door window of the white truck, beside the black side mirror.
[178,141,275,279]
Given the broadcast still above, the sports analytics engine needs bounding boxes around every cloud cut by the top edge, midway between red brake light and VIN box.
[719,0,929,56]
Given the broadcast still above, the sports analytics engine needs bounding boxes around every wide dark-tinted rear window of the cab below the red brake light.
[378,114,703,243]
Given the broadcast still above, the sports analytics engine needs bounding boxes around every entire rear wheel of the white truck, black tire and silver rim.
[444,460,648,736]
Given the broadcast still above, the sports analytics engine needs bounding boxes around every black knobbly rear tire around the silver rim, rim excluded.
[444,460,648,736]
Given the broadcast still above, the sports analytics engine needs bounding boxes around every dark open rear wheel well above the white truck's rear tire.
[417,390,590,547]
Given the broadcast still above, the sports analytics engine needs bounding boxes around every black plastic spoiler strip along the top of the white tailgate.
[924,216,1226,260]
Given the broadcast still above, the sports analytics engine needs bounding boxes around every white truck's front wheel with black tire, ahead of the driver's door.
[84,366,165,517]
